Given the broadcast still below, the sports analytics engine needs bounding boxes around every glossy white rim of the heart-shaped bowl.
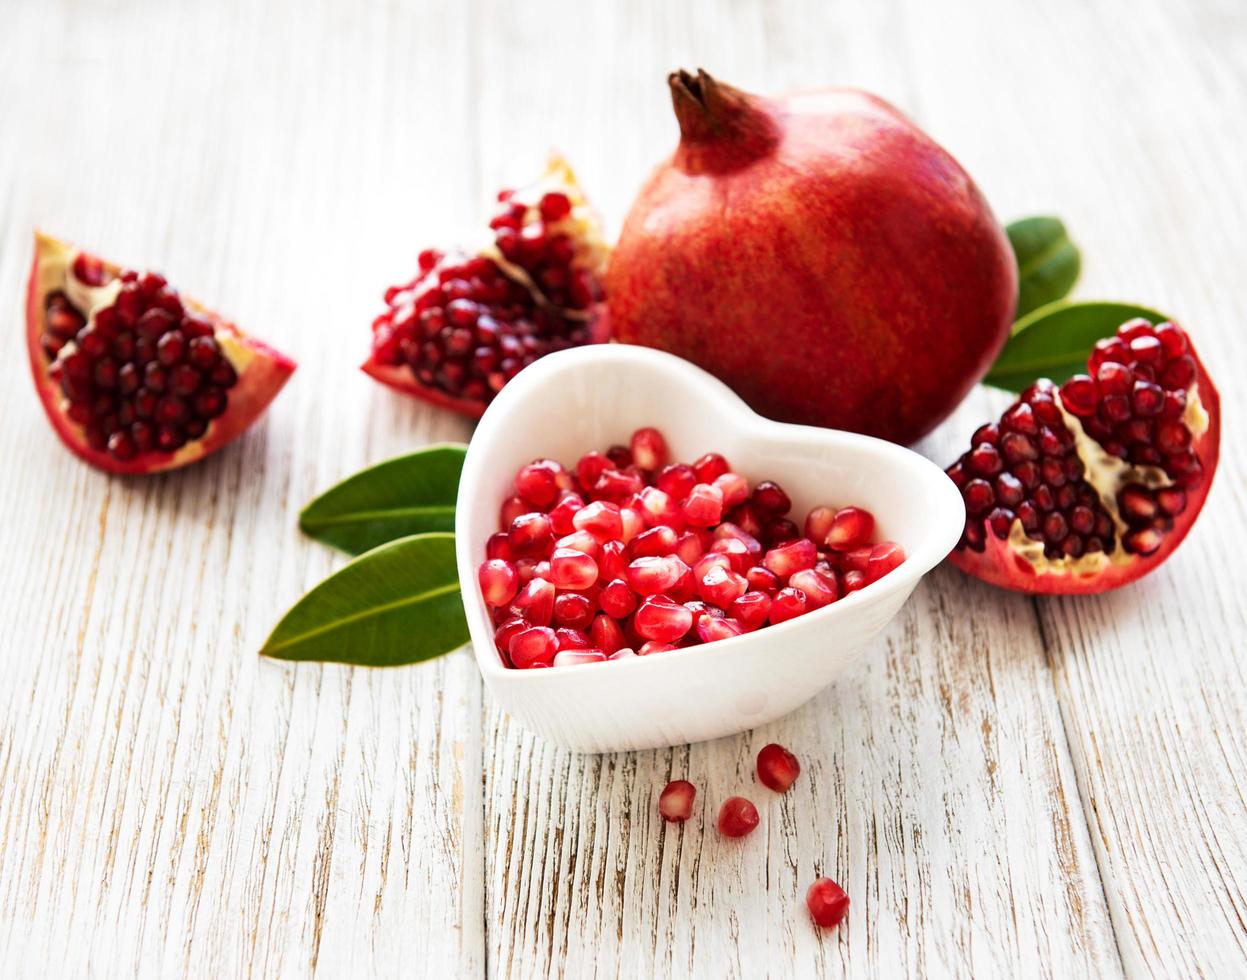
[455,343,965,685]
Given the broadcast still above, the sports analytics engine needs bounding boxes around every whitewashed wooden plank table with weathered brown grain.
[0,0,1247,978]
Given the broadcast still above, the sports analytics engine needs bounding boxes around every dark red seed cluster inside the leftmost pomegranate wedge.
[41,254,238,460]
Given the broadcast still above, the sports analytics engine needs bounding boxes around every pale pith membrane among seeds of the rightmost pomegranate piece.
[1007,382,1208,576]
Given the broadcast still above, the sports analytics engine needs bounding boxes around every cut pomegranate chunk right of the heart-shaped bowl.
[948,319,1221,595]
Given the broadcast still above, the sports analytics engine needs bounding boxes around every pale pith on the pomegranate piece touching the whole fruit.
[478,153,611,320]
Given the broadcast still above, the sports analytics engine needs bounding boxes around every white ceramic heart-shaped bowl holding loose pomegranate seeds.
[455,344,965,752]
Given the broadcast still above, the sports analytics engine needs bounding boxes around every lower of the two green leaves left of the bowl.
[259,534,468,667]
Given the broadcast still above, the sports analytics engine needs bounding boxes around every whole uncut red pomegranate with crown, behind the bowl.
[606,71,1018,443]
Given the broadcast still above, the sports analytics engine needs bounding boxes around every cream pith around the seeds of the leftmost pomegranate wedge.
[36,234,256,463]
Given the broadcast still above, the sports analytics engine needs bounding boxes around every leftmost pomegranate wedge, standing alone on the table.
[26,233,294,473]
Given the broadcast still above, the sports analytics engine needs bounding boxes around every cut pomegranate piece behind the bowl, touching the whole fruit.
[363,157,610,418]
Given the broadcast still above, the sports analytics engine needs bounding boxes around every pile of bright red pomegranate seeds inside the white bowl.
[479,428,905,668]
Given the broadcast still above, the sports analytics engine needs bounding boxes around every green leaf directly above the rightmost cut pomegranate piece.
[983,302,1168,392]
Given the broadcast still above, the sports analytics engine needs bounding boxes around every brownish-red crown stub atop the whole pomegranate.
[667,69,779,173]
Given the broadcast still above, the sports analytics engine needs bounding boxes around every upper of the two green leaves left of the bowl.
[299,444,466,555]
